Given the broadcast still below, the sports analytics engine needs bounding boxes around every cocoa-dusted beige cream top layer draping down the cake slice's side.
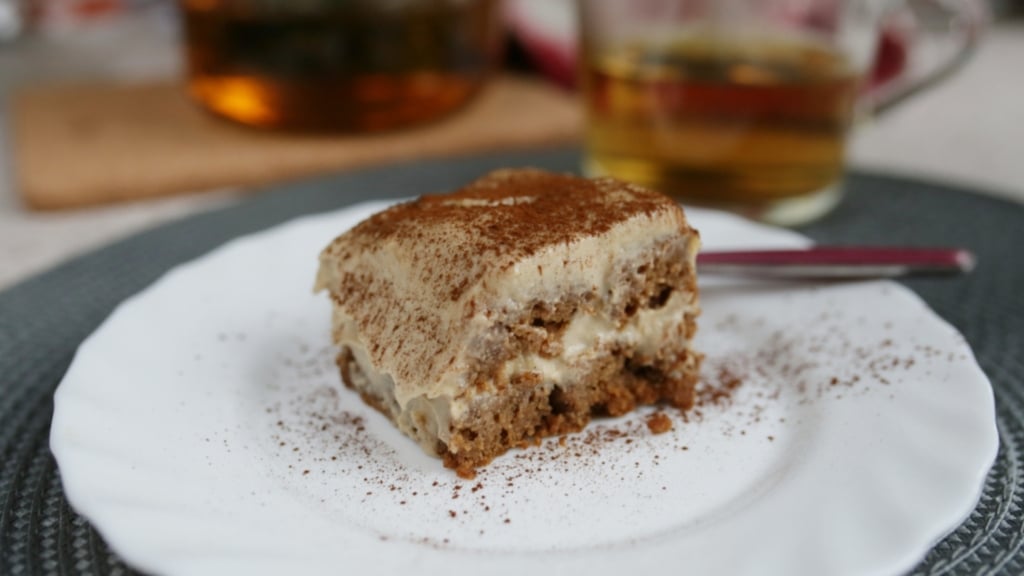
[317,170,696,403]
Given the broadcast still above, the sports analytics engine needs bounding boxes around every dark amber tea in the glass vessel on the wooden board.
[182,0,500,131]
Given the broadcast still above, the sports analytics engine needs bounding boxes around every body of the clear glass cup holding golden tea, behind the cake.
[580,0,978,224]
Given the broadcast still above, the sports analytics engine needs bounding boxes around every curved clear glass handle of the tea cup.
[866,0,986,115]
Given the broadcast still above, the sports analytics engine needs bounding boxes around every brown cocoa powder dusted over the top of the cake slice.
[326,169,679,300]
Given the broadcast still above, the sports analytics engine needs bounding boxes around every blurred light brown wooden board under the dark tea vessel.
[10,76,582,209]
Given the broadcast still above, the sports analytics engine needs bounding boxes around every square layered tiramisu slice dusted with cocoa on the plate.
[316,170,699,476]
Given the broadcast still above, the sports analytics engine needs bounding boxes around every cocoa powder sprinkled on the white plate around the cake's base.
[264,291,962,548]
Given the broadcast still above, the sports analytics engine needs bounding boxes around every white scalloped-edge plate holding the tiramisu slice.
[51,204,998,575]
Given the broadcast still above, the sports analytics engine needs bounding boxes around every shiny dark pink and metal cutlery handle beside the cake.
[697,246,975,279]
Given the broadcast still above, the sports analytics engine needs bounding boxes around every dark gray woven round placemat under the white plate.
[0,150,1024,575]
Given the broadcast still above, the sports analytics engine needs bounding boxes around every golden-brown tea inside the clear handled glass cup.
[585,38,858,206]
